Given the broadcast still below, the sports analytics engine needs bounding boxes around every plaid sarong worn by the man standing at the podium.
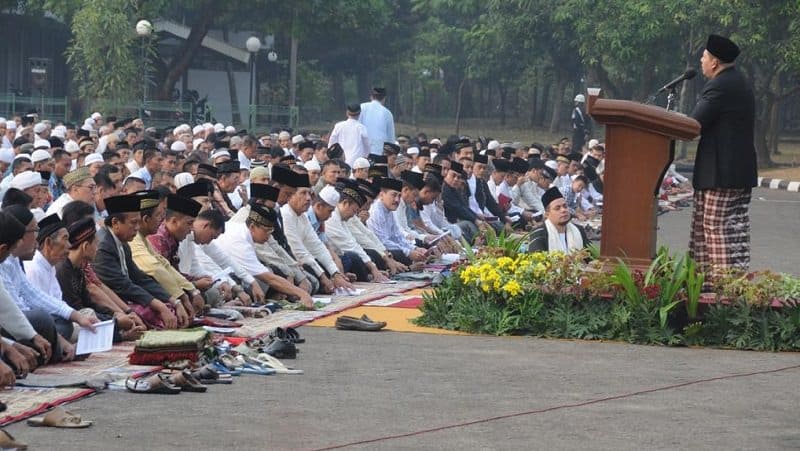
[689,188,751,276]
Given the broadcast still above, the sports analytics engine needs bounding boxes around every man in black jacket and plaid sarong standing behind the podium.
[689,34,758,274]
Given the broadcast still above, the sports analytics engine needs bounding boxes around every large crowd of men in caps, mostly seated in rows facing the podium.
[0,90,604,385]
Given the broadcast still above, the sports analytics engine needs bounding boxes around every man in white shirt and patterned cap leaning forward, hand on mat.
[214,205,314,308]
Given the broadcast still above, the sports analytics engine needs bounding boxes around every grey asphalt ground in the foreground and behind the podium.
[7,185,800,450]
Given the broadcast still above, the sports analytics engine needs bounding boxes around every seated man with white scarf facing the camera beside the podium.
[528,186,589,254]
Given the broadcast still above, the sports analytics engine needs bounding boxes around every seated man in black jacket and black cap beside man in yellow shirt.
[94,194,178,329]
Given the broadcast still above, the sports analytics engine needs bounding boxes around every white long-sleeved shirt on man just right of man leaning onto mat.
[281,204,339,276]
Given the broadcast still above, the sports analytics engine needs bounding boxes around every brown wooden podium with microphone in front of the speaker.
[588,88,700,267]
